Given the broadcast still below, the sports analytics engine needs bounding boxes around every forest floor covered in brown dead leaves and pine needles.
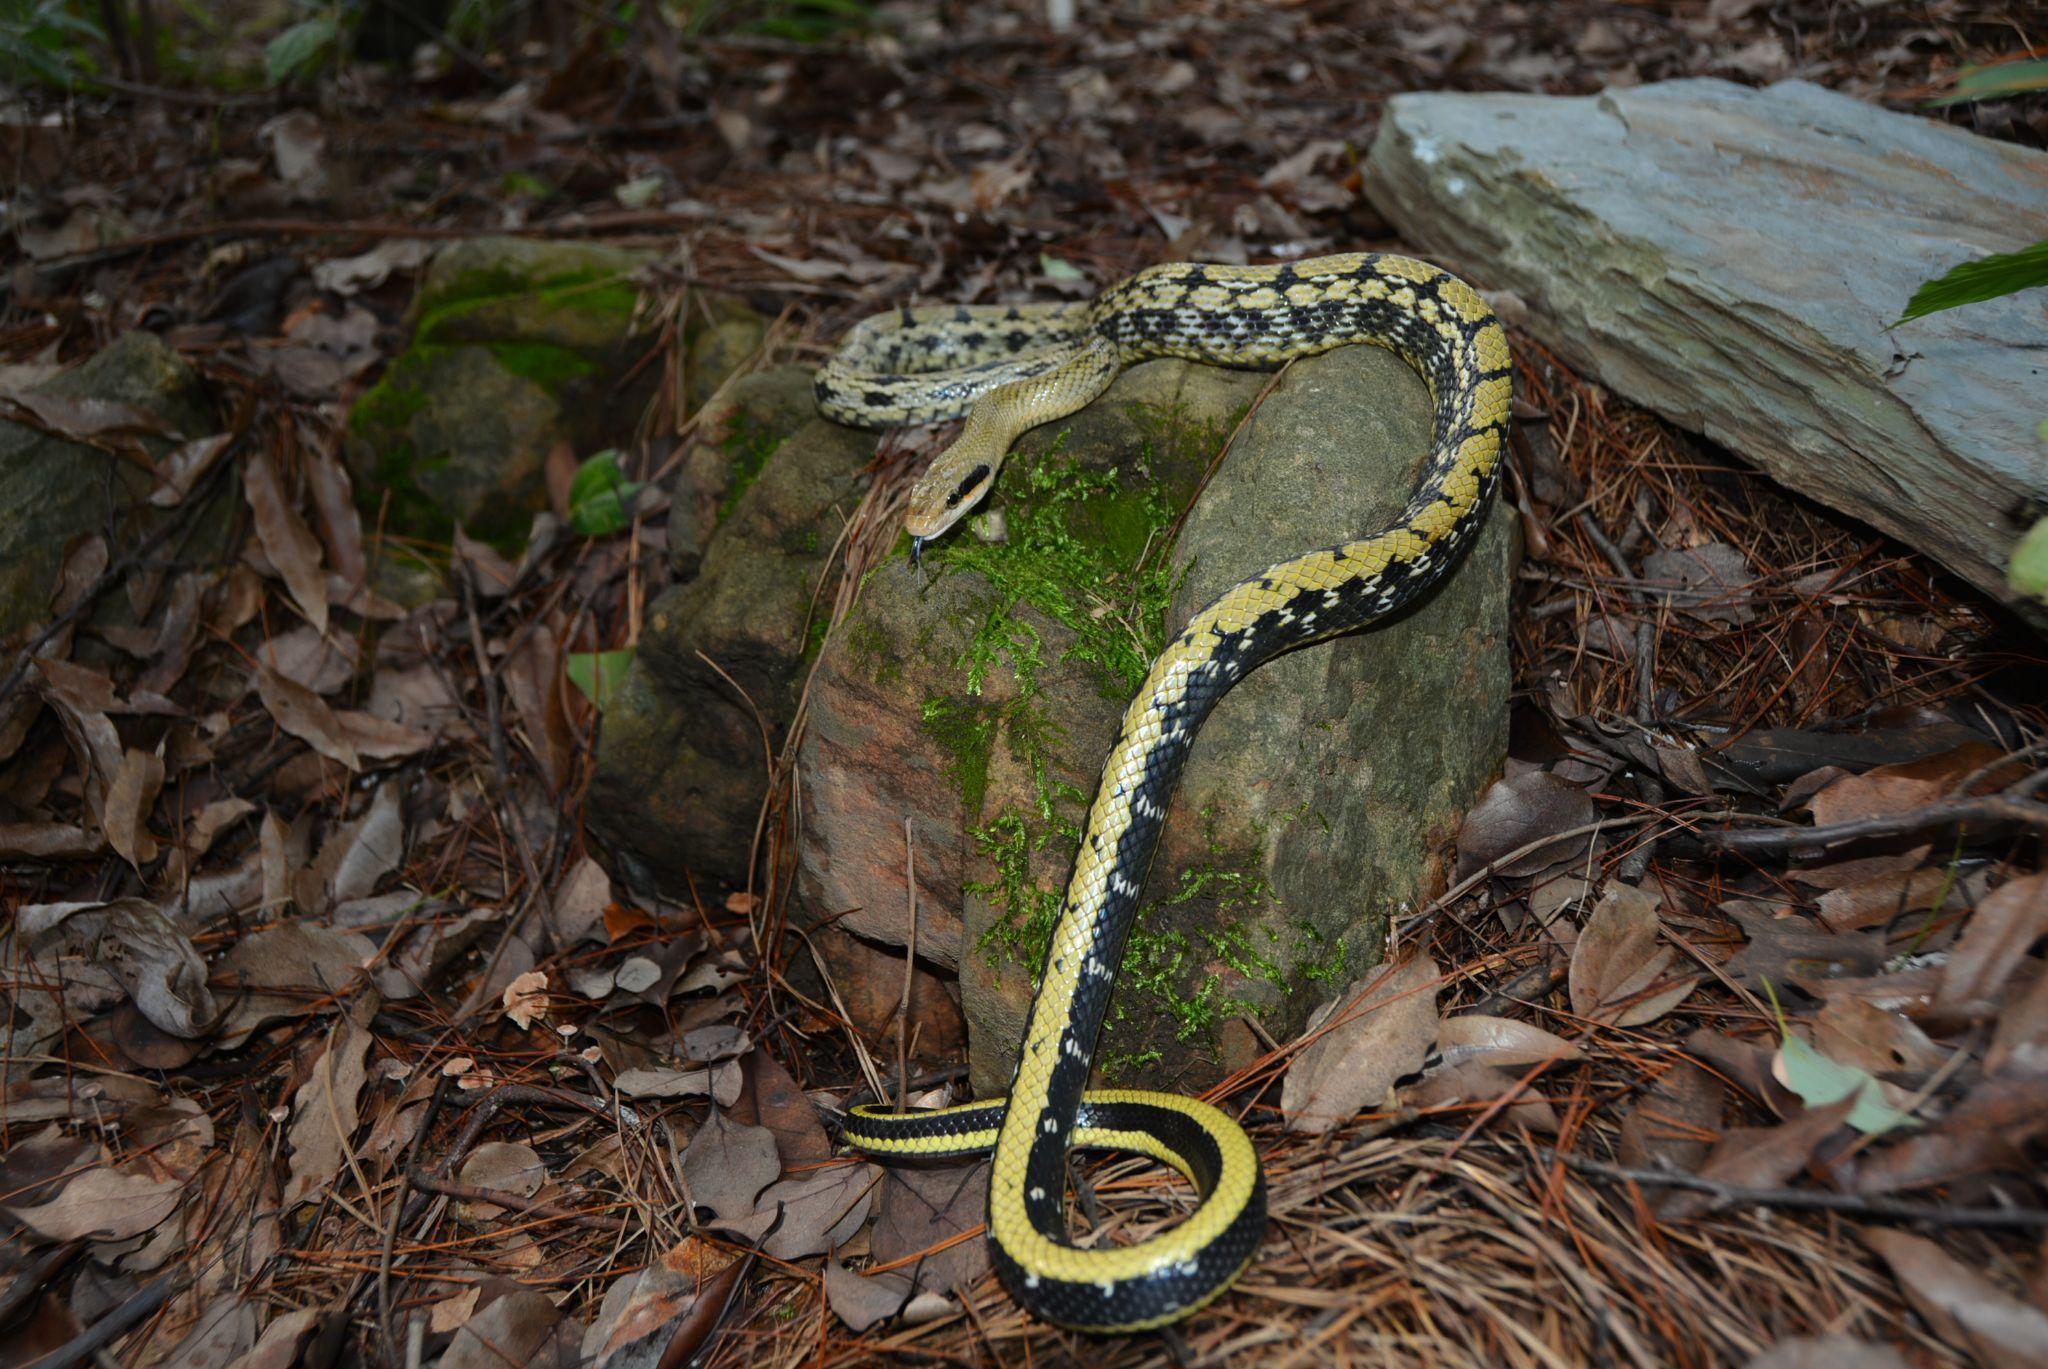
[0,0,2048,1369]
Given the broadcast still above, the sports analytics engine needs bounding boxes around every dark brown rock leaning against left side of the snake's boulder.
[588,385,874,889]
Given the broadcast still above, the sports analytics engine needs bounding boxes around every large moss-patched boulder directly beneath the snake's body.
[799,348,1513,1092]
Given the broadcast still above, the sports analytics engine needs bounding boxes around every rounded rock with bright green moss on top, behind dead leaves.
[348,238,653,543]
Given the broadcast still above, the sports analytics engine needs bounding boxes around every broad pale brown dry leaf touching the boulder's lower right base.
[1280,955,1444,1131]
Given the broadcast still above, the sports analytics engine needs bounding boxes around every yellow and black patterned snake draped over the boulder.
[815,252,1513,1334]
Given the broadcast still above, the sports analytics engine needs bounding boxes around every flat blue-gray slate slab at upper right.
[1366,80,2048,627]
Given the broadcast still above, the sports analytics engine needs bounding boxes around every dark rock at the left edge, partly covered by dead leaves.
[0,332,222,641]
